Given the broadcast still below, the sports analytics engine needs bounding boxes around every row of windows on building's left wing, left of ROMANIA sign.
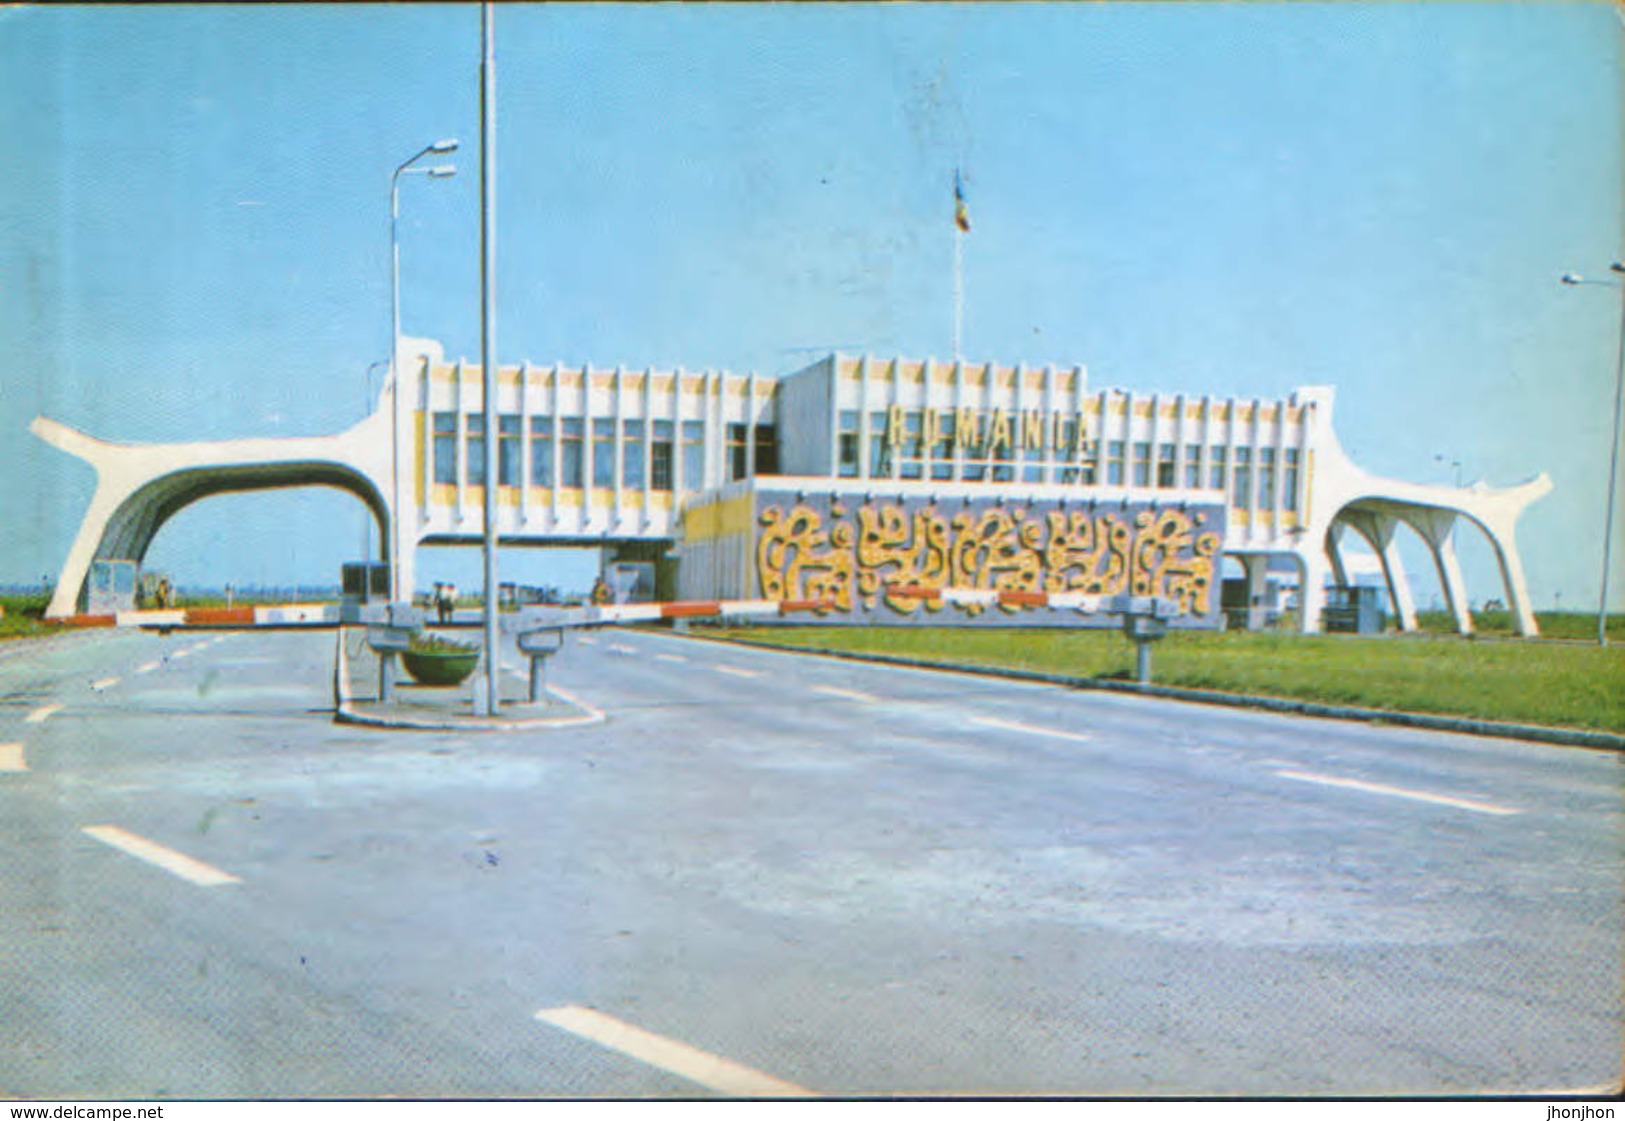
[434,413,778,491]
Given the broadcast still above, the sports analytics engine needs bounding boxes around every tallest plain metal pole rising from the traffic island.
[475,0,502,716]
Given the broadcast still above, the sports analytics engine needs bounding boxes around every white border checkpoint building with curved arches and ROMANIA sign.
[33,340,1552,635]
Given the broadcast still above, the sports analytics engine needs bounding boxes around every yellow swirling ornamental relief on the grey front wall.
[756,502,1219,616]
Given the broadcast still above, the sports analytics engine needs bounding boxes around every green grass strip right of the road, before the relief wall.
[712,619,1625,733]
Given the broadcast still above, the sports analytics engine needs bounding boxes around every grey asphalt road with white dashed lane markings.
[0,630,1625,1098]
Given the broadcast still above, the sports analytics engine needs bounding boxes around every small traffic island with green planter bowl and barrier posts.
[333,627,605,731]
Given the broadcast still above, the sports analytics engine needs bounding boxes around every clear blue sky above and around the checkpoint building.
[0,2,1625,609]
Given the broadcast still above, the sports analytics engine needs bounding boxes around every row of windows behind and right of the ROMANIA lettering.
[837,411,1300,510]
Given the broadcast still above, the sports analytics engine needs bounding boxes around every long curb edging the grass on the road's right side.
[689,632,1625,752]
